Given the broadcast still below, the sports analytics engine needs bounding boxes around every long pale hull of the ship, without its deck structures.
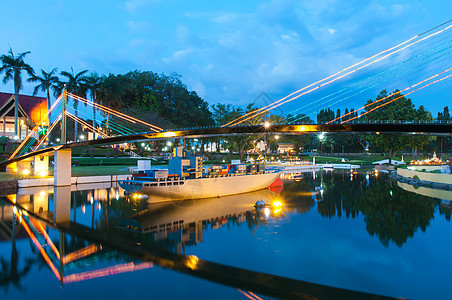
[119,172,281,202]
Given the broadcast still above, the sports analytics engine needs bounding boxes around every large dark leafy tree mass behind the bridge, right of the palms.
[98,70,213,127]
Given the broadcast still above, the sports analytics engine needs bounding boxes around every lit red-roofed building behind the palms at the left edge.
[0,92,49,139]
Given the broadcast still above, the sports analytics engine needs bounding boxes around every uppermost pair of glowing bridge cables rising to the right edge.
[225,25,452,127]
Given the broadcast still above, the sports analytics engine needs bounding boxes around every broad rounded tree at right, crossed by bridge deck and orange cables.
[361,90,432,164]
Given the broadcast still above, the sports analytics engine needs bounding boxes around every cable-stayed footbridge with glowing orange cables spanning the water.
[0,21,452,185]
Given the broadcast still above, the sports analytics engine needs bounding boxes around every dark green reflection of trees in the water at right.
[282,172,441,247]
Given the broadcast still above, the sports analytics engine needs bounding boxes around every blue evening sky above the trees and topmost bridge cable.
[0,0,452,115]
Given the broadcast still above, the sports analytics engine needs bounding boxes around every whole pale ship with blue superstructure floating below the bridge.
[118,149,281,203]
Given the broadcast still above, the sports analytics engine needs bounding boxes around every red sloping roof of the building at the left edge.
[0,92,47,123]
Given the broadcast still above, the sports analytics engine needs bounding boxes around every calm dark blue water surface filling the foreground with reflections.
[0,171,452,299]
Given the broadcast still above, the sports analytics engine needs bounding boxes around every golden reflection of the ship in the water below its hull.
[118,190,279,253]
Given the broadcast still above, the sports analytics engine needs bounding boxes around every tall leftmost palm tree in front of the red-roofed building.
[0,47,34,136]
